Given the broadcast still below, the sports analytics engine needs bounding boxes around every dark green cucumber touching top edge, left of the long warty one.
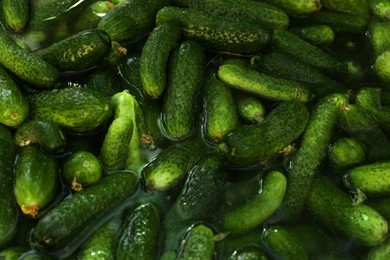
[98,0,172,43]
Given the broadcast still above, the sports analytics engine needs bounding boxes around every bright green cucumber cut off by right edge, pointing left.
[343,161,390,197]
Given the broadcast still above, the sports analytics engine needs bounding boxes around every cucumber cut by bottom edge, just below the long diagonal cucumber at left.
[79,217,121,260]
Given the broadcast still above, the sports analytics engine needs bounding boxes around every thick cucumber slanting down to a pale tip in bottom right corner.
[307,178,388,247]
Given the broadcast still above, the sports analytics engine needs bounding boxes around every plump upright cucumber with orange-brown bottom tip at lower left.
[14,145,60,218]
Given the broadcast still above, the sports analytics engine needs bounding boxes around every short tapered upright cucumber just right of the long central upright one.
[203,73,239,142]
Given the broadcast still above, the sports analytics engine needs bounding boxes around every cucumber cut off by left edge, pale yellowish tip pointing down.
[0,67,29,127]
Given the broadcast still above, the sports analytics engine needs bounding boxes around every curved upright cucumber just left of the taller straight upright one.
[140,22,181,98]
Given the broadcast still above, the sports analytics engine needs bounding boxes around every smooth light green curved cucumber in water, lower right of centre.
[222,171,287,234]
